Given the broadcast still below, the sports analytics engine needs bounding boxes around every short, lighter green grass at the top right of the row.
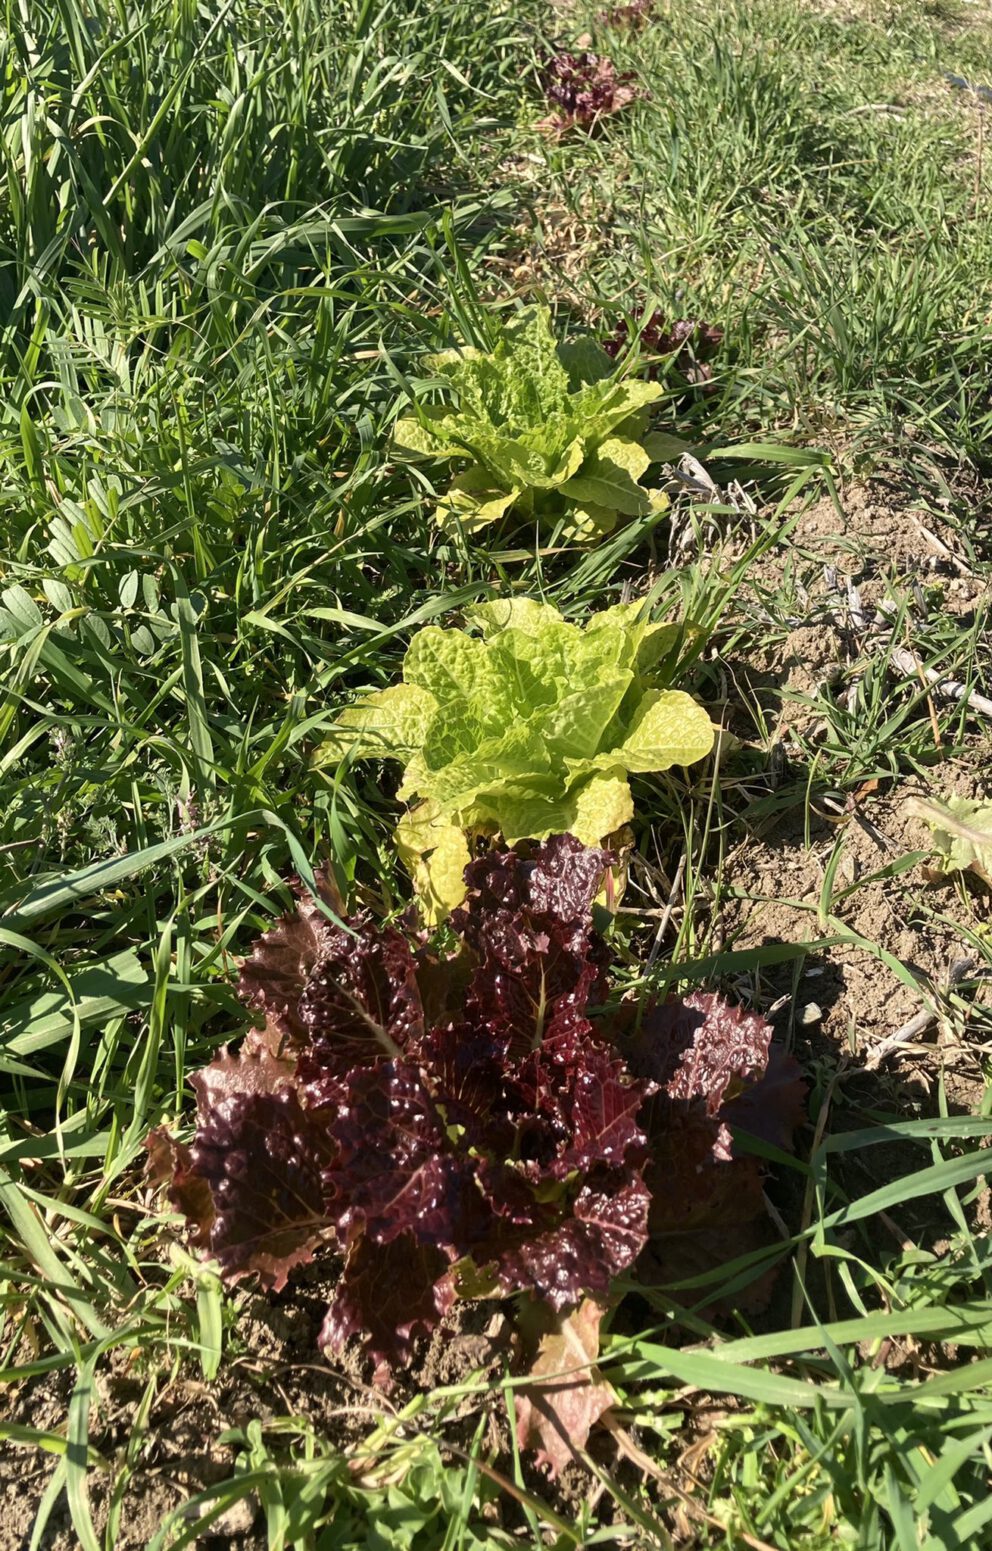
[538,0,989,461]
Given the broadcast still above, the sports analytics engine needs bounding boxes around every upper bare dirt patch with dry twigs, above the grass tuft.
[724,481,992,753]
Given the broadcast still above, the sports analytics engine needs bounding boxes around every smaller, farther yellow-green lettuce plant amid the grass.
[394,307,685,540]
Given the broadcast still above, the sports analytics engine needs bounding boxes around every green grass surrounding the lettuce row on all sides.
[0,0,992,1551]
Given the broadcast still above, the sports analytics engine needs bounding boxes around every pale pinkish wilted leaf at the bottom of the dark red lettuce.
[515,1298,615,1477]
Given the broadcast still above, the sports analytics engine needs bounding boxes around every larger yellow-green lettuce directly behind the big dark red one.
[318,599,715,921]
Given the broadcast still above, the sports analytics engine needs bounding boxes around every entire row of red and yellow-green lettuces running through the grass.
[149,3,803,1470]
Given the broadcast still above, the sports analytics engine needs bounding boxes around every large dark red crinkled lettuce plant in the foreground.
[149,843,801,1389]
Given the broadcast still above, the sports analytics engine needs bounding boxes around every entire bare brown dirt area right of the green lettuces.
[706,479,992,1098]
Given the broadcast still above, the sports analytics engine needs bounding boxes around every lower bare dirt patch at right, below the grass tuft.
[721,771,992,1060]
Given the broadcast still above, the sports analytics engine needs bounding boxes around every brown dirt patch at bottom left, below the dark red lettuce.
[0,1263,513,1551]
